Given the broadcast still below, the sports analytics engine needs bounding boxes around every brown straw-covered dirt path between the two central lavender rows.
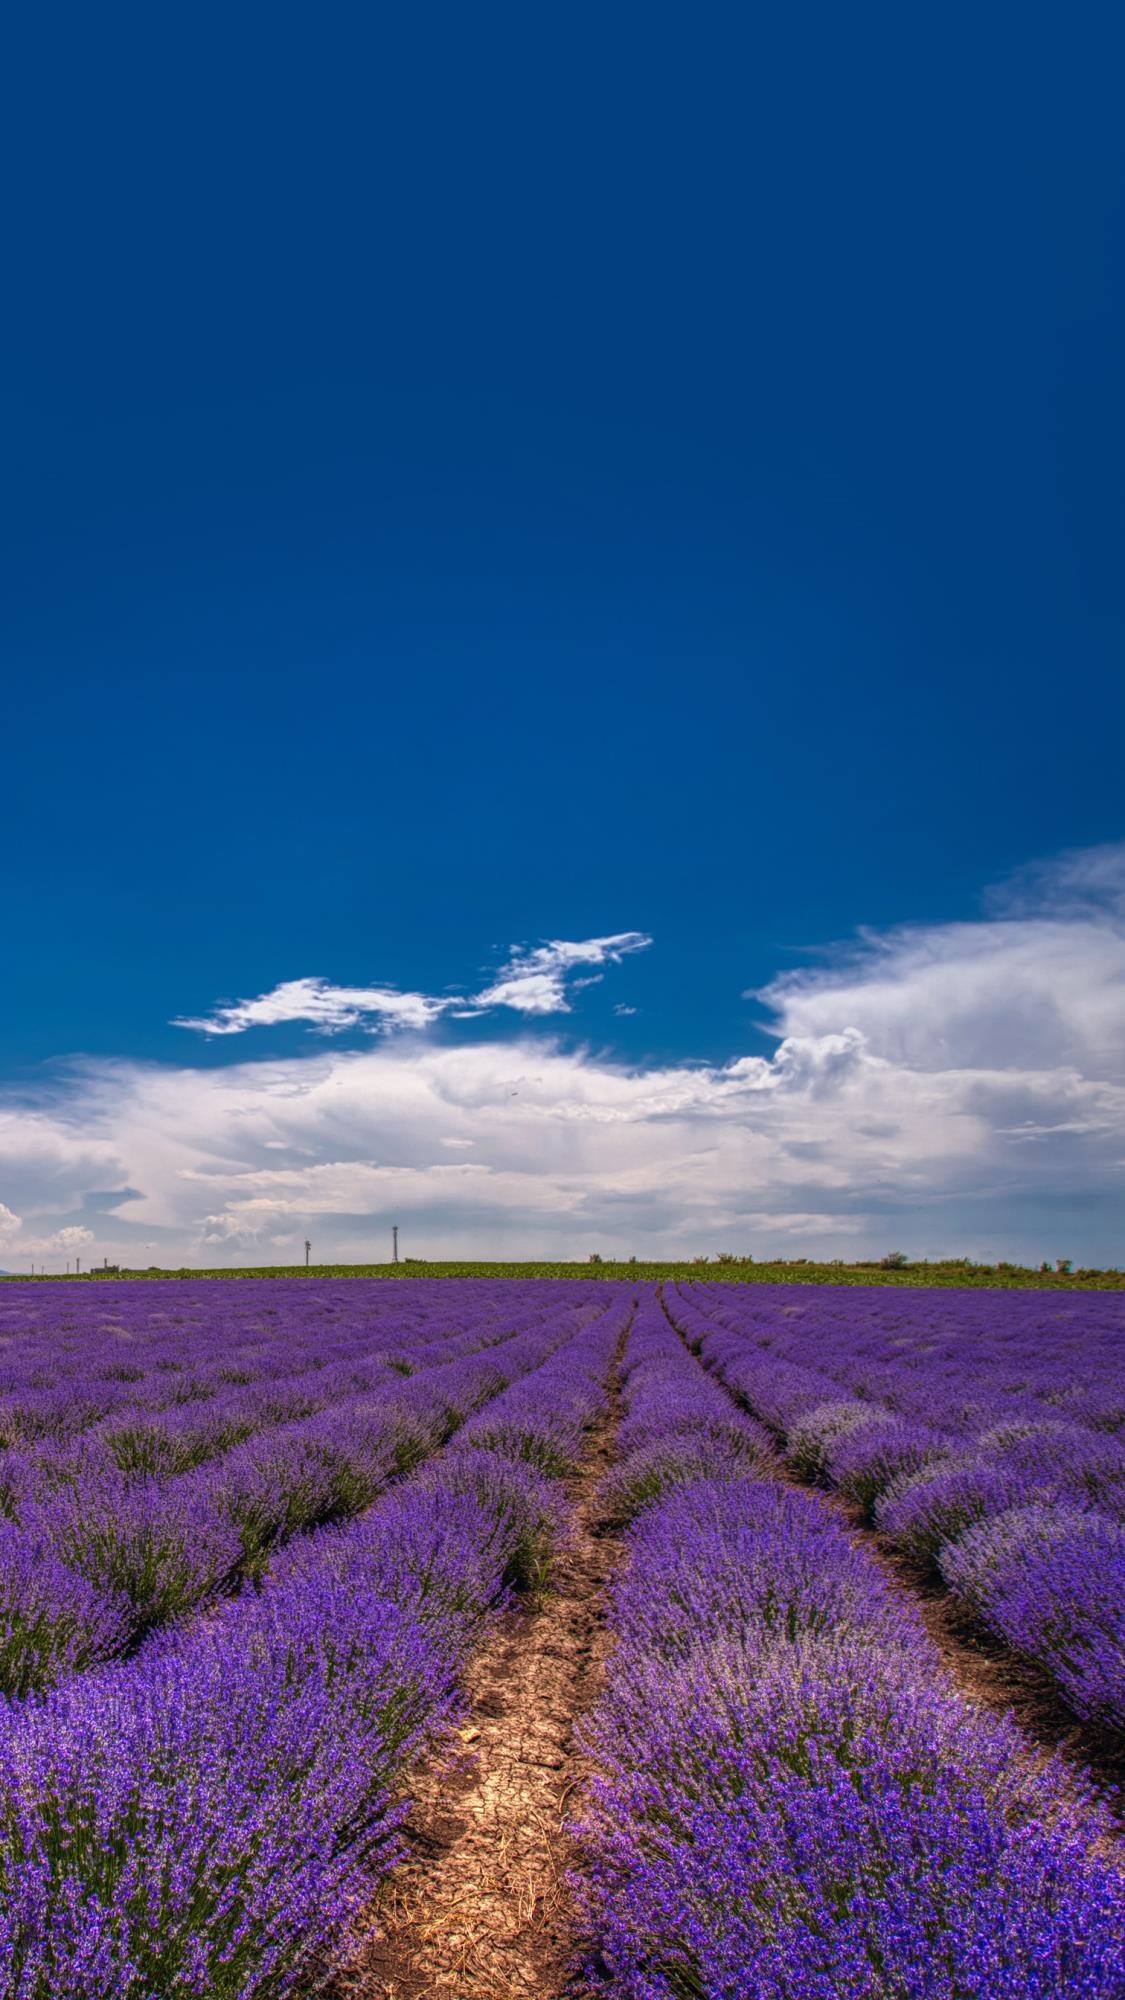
[344,1370,619,2000]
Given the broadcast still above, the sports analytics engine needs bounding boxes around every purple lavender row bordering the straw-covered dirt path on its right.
[585,1298,1125,2000]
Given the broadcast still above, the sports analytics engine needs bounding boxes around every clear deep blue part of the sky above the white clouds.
[0,6,1125,1080]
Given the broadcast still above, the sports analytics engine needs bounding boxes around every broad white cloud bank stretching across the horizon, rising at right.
[0,848,1125,1264]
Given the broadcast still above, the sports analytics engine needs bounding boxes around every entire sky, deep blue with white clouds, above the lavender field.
[0,8,1125,1268]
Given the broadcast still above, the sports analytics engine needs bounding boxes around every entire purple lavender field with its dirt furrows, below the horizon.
[0,1278,1125,2000]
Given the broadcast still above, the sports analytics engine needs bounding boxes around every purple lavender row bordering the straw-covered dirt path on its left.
[0,1288,631,2000]
